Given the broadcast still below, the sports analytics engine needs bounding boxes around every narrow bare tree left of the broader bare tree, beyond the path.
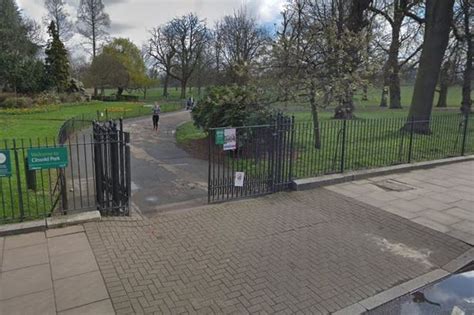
[147,25,176,97]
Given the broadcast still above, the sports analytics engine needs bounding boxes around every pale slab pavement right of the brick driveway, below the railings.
[327,161,474,245]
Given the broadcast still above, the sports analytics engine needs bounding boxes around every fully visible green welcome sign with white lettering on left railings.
[28,147,68,171]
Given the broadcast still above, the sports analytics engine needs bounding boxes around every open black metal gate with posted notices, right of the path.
[208,115,294,203]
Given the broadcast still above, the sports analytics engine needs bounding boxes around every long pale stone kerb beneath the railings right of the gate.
[291,155,474,190]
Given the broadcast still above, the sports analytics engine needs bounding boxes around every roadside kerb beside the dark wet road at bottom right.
[333,248,474,315]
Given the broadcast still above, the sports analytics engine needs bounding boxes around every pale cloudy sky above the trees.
[17,0,285,58]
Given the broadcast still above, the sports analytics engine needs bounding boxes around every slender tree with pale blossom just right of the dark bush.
[272,0,367,148]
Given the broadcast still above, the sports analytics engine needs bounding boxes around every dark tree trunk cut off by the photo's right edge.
[461,0,474,115]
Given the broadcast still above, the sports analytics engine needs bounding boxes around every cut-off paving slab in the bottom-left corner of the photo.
[0,289,56,315]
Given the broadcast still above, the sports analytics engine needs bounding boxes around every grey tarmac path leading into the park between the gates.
[124,111,208,215]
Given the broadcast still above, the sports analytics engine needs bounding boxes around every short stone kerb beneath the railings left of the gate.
[0,211,101,236]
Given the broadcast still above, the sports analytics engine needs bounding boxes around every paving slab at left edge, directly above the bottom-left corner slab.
[0,264,53,300]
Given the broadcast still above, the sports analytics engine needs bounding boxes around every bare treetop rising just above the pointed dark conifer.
[43,0,74,42]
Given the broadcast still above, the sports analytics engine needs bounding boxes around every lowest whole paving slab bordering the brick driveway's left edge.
[54,271,109,312]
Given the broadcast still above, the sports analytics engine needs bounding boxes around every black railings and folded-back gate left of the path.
[0,118,131,223]
